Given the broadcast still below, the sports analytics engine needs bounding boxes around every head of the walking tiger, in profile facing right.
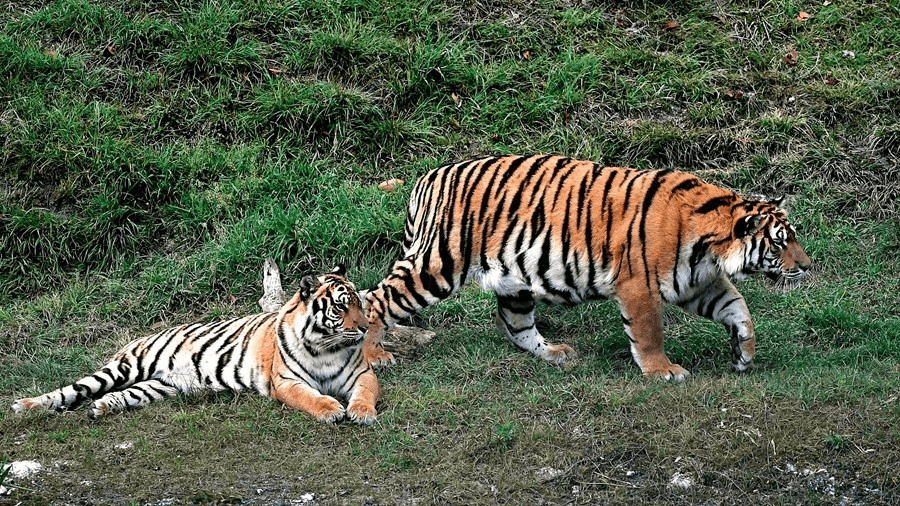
[733,197,811,290]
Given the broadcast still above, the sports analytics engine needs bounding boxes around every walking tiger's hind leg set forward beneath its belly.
[494,290,575,365]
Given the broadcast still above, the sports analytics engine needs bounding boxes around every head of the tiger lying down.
[298,265,368,352]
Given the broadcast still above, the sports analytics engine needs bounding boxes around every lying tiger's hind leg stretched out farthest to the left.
[12,363,134,413]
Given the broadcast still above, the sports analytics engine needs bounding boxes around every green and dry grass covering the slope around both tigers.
[0,0,900,504]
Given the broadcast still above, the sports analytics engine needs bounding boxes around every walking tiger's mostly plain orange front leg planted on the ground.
[618,288,690,381]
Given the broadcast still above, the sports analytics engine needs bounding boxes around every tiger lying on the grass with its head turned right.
[12,265,379,424]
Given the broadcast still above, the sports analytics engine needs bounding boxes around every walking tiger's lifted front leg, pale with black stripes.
[679,277,756,372]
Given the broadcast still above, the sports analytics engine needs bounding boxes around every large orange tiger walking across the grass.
[363,156,810,381]
